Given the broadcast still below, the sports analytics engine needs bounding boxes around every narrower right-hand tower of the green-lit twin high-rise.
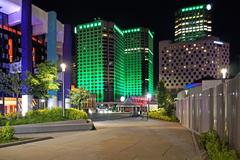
[123,28,153,96]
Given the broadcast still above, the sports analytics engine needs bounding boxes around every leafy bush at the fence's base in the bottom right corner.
[200,130,237,160]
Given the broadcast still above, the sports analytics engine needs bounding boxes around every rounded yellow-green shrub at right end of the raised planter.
[66,108,88,120]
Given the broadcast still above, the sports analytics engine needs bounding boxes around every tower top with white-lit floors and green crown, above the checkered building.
[175,4,212,42]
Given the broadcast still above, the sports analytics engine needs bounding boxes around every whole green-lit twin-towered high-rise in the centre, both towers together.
[72,20,153,104]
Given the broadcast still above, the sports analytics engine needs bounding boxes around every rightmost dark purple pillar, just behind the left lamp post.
[62,24,73,108]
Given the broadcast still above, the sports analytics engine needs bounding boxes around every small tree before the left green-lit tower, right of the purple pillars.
[70,88,90,110]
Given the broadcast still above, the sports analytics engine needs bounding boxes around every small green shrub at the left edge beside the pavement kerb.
[0,123,15,142]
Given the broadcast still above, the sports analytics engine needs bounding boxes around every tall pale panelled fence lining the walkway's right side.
[176,74,240,150]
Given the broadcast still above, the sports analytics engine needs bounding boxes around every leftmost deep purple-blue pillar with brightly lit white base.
[21,0,32,116]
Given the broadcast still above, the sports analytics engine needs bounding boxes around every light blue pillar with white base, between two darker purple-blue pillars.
[47,11,57,109]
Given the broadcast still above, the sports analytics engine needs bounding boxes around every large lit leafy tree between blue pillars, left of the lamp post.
[26,62,59,108]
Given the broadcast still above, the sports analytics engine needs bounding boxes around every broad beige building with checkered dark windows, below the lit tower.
[159,37,229,89]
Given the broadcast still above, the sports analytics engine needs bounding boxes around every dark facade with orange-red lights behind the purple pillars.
[0,12,47,72]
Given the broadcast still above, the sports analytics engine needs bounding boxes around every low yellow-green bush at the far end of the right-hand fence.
[149,108,178,122]
